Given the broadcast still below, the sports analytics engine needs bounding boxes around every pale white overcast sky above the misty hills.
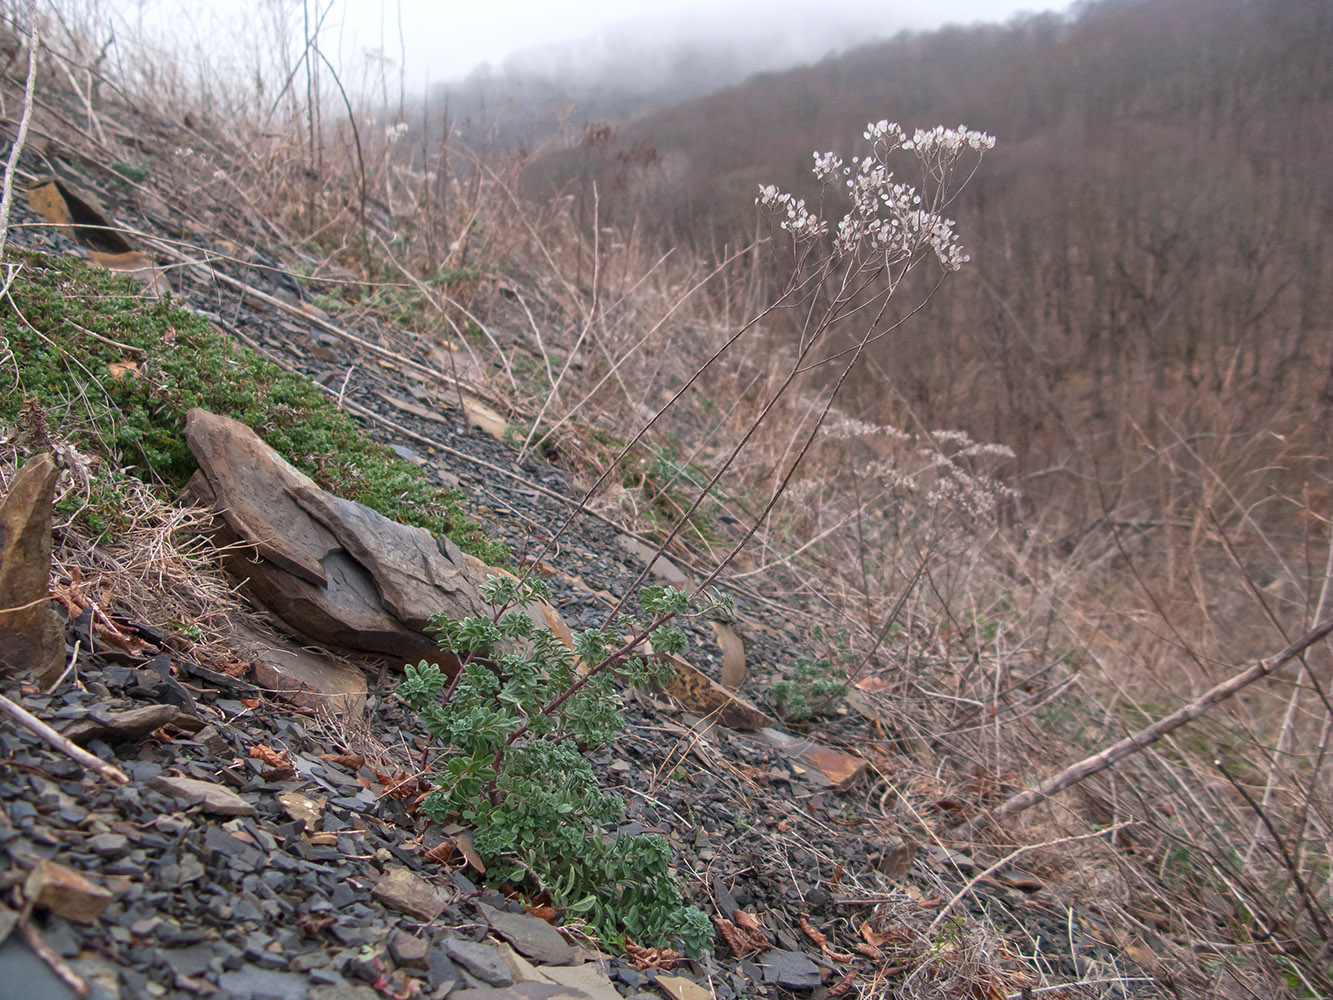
[113,0,1069,91]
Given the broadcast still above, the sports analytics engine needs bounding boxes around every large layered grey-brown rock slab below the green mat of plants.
[185,409,485,669]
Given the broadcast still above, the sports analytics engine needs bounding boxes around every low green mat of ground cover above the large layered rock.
[0,253,508,563]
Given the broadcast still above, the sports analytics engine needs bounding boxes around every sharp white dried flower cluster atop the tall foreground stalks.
[754,119,996,271]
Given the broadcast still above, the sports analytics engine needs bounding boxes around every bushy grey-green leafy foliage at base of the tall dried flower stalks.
[399,577,729,956]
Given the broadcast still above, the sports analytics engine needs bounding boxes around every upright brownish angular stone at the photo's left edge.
[0,452,65,687]
